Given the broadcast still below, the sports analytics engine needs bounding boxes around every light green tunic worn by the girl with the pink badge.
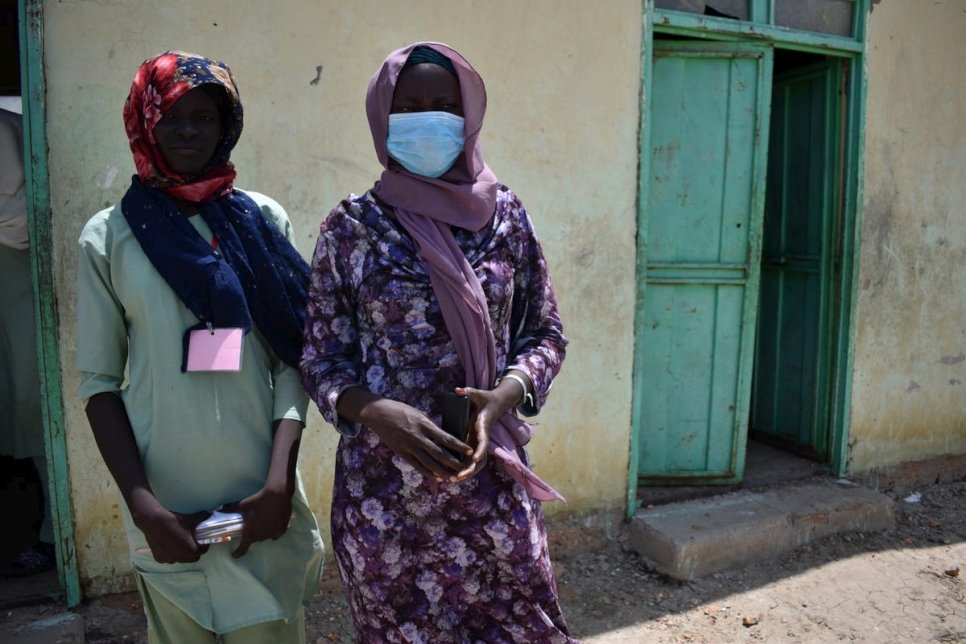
[77,192,322,633]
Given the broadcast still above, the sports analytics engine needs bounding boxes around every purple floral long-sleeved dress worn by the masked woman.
[302,187,574,644]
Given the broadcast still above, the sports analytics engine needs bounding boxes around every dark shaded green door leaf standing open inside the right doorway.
[751,61,841,461]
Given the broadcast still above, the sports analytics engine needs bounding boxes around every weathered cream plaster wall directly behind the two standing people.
[44,0,641,594]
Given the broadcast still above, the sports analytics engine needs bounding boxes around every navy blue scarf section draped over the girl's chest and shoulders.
[121,176,309,371]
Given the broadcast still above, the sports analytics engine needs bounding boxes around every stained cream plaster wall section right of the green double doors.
[849,0,966,473]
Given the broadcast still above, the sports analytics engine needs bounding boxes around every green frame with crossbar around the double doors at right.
[627,0,870,517]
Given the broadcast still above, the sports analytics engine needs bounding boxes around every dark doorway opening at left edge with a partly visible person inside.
[0,0,69,607]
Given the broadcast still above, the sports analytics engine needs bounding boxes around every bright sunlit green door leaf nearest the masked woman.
[635,41,772,483]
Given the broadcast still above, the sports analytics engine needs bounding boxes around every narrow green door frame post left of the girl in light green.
[18,0,81,607]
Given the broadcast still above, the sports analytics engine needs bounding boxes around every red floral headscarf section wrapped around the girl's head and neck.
[124,51,243,203]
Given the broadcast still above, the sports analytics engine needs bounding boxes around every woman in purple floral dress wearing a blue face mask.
[301,43,573,643]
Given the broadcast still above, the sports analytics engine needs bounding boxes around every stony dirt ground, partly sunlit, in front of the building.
[0,480,966,644]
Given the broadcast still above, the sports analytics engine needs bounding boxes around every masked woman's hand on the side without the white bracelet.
[360,391,473,481]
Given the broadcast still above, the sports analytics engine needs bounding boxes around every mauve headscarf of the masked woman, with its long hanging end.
[366,42,564,501]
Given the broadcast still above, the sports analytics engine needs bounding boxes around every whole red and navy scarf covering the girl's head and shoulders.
[121,51,309,366]
